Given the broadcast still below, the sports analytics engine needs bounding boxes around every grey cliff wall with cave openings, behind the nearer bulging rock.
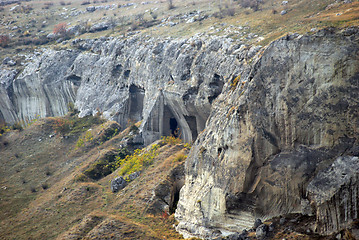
[0,37,253,144]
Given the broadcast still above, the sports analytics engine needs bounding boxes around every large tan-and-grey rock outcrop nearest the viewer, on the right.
[176,28,359,238]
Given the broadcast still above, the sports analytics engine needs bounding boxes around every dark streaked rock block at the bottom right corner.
[307,156,359,234]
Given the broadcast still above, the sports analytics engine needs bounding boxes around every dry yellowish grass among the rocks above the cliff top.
[0,0,359,60]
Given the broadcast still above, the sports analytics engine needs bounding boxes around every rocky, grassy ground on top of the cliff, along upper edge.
[0,0,359,68]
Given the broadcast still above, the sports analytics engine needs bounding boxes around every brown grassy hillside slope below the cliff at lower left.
[0,115,188,239]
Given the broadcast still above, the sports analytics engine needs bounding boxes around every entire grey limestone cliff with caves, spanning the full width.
[0,28,359,238]
